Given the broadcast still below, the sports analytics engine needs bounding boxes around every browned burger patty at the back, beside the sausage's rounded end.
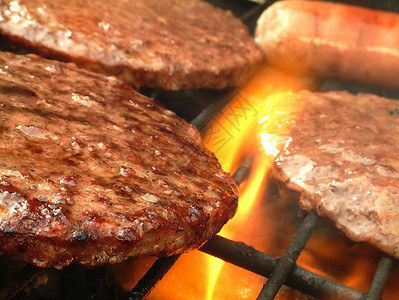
[0,0,263,90]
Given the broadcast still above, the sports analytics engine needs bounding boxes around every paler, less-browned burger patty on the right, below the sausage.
[272,92,399,258]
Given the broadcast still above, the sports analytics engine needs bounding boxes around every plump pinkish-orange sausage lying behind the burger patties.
[255,0,399,89]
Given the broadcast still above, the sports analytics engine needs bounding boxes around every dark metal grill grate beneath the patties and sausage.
[0,0,398,300]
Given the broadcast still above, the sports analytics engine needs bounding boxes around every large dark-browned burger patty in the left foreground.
[0,52,238,268]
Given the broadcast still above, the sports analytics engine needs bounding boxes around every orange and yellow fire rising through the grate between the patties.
[122,64,399,300]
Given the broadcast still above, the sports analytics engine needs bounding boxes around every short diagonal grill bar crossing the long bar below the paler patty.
[257,211,318,300]
